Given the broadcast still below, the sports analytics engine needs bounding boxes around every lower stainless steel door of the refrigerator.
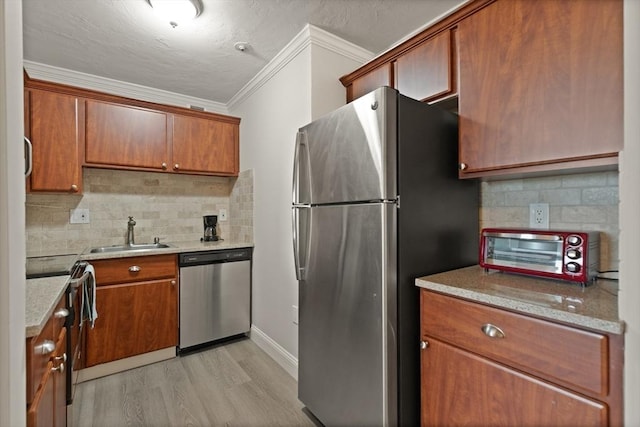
[298,203,396,426]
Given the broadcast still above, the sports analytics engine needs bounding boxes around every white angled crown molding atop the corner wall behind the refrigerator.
[227,24,374,110]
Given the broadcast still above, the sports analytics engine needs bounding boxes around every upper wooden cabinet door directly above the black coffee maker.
[172,114,239,175]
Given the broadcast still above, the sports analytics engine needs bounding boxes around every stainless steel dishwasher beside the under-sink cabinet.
[179,248,252,353]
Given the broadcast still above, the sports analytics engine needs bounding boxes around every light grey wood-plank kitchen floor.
[73,338,316,427]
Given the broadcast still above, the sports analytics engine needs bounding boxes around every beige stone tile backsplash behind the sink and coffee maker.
[26,168,253,256]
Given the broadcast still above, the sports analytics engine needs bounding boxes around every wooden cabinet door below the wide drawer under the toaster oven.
[421,339,608,427]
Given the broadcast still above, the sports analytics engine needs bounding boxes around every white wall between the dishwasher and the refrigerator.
[231,28,364,377]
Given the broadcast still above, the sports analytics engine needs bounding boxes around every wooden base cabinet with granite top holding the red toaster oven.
[416,266,623,426]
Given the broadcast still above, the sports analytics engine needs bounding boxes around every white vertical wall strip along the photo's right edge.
[618,0,640,427]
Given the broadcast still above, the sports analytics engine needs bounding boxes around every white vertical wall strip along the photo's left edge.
[0,1,26,426]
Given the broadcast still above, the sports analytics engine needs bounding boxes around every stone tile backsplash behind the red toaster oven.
[480,172,620,270]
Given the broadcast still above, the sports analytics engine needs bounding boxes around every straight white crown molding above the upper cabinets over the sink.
[23,60,229,114]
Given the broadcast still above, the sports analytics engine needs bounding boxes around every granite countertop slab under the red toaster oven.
[416,265,624,334]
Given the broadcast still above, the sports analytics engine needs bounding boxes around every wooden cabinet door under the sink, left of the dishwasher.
[86,280,178,367]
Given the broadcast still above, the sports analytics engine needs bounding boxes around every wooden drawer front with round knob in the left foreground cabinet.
[26,297,66,404]
